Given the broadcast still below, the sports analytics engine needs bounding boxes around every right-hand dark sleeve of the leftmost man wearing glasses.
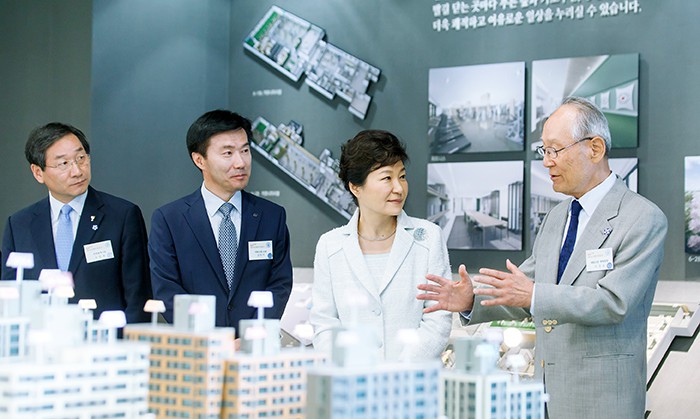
[120,205,152,323]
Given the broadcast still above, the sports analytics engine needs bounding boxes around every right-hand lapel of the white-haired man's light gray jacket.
[561,179,627,285]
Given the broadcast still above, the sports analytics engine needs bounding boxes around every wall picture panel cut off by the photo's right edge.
[684,156,700,278]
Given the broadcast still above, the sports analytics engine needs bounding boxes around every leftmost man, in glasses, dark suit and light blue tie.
[2,122,152,323]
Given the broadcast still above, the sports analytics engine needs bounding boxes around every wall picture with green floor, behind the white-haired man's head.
[530,54,639,158]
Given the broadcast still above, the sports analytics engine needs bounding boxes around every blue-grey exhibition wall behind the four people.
[0,0,700,280]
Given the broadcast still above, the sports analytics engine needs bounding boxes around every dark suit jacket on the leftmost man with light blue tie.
[2,187,151,323]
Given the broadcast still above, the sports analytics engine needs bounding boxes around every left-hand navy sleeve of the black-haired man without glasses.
[148,209,189,323]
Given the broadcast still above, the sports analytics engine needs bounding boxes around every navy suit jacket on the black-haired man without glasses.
[148,189,292,330]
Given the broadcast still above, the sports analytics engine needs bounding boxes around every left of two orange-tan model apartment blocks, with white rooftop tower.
[124,295,235,419]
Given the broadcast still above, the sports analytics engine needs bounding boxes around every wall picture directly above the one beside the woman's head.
[428,62,525,154]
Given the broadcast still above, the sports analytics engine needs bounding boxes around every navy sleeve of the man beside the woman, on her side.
[265,209,292,319]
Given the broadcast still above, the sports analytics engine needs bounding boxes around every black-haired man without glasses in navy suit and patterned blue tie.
[148,110,292,329]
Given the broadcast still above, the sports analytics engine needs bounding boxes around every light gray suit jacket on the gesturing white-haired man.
[471,179,667,419]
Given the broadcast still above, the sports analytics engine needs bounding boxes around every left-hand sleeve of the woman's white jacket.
[309,236,340,353]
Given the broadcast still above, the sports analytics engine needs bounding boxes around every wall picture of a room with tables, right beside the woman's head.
[428,161,524,250]
